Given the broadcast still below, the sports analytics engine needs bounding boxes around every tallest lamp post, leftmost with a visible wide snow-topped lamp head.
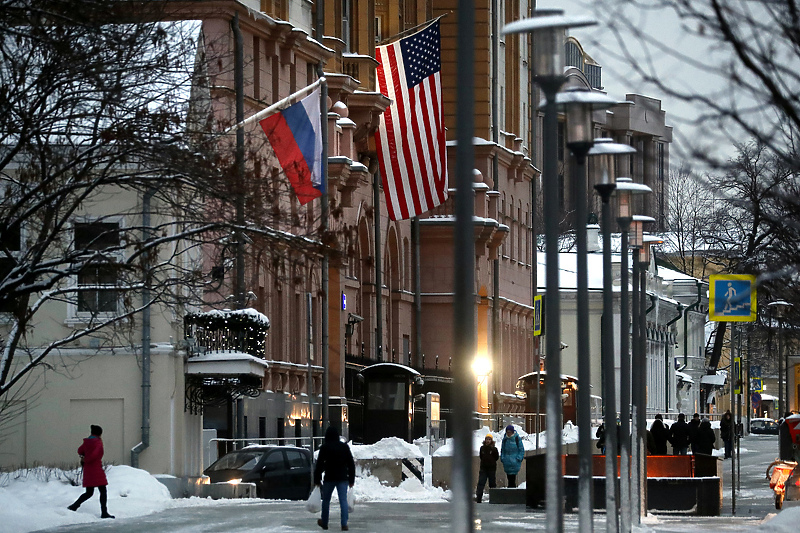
[503,10,595,533]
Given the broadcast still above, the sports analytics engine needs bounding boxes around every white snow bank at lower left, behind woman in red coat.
[0,466,171,533]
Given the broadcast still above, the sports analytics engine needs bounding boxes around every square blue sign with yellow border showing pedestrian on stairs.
[708,274,756,322]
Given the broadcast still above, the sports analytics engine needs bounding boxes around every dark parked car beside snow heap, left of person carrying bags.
[203,446,313,500]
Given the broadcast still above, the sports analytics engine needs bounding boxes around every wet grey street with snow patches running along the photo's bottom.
[37,436,788,533]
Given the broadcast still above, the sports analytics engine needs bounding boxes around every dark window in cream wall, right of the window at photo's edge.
[74,221,120,314]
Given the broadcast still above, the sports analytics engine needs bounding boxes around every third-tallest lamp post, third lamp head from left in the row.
[589,139,635,533]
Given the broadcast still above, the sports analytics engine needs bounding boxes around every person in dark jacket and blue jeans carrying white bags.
[314,426,356,531]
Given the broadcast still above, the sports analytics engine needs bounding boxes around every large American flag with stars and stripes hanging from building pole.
[375,20,447,220]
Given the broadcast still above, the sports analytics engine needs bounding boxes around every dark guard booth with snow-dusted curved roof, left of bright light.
[360,363,422,444]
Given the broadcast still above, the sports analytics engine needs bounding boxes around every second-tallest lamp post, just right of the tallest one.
[556,88,618,533]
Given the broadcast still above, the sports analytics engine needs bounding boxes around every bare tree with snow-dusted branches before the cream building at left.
[0,0,328,414]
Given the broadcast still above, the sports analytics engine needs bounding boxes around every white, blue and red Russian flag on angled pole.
[259,88,325,205]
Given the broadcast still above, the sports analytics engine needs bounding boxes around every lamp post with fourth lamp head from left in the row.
[615,177,652,533]
